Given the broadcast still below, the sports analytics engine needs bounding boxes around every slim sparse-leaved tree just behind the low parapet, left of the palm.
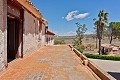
[74,22,87,47]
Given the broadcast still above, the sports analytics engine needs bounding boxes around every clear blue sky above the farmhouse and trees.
[31,0,120,36]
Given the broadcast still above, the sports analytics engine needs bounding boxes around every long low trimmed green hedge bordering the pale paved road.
[84,54,120,61]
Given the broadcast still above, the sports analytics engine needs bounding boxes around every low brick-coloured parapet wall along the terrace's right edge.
[69,45,116,80]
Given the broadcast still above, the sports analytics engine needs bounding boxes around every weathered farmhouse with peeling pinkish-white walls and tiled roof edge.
[0,0,55,70]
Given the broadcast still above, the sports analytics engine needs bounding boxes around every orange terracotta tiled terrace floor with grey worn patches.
[0,46,96,80]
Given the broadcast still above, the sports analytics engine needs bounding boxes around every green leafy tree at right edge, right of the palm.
[109,22,120,44]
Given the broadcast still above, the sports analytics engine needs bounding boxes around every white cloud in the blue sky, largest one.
[65,10,89,21]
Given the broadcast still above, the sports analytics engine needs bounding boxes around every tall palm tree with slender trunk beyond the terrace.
[94,10,108,54]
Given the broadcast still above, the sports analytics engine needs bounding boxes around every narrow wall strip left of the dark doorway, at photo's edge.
[0,0,7,71]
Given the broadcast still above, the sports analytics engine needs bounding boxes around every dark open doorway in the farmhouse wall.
[7,16,19,62]
